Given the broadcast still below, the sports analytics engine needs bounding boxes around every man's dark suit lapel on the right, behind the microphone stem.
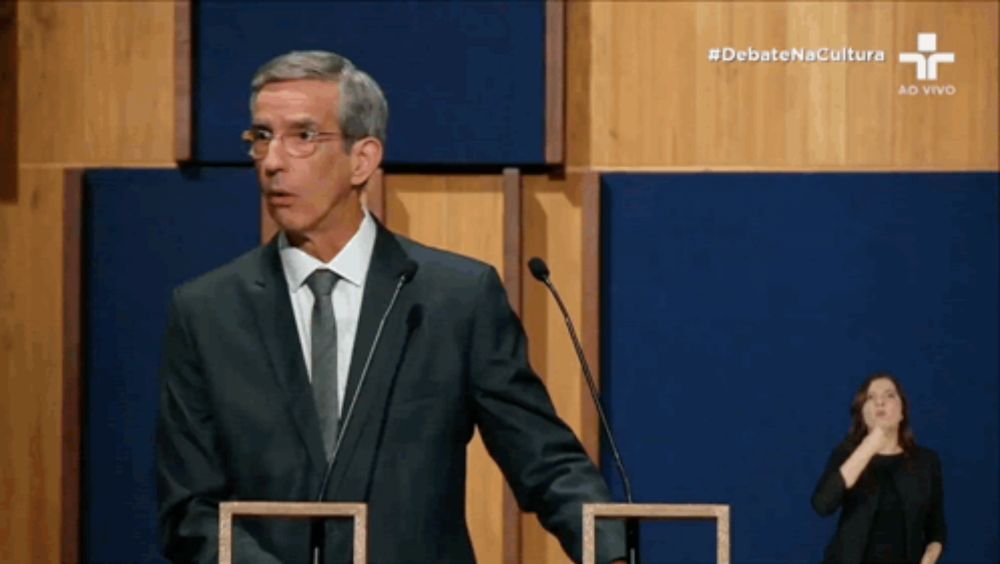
[329,225,413,500]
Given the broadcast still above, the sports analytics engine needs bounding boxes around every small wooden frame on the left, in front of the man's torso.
[219,501,368,564]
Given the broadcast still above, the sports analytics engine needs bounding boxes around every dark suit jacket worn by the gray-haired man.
[157,226,624,563]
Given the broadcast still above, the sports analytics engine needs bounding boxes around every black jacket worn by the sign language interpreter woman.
[812,443,947,563]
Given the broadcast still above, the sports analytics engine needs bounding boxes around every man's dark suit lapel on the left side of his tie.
[250,238,326,475]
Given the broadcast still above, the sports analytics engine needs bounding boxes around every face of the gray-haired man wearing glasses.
[253,80,358,236]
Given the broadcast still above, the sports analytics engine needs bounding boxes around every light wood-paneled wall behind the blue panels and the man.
[0,1,998,564]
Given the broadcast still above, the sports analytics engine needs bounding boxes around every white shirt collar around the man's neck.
[278,210,378,292]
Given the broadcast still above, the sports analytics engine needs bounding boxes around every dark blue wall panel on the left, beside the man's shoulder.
[81,168,260,562]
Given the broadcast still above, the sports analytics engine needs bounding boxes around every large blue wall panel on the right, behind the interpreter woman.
[601,173,1000,563]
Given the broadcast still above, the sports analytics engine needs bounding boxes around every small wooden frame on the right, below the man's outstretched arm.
[583,503,730,564]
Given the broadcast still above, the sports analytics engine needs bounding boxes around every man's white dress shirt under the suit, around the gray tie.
[278,210,377,412]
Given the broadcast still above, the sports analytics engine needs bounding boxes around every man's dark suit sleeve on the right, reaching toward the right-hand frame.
[469,268,625,562]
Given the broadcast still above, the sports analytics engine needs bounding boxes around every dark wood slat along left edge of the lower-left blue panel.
[60,169,83,562]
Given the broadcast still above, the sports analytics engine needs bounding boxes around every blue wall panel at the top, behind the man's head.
[193,0,545,165]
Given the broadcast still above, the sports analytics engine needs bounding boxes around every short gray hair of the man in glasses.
[250,51,389,150]
